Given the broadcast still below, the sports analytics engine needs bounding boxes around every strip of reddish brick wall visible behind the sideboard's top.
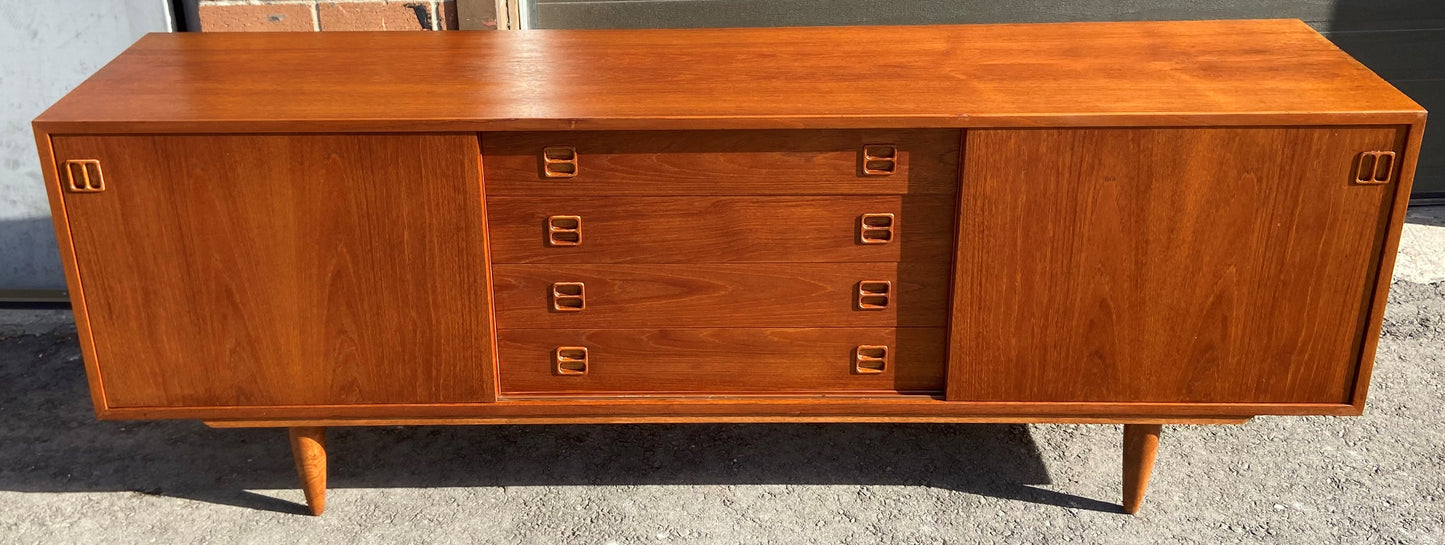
[197,0,457,32]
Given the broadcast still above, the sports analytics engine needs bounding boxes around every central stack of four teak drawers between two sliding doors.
[483,130,959,398]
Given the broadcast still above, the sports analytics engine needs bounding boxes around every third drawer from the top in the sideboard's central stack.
[493,263,948,328]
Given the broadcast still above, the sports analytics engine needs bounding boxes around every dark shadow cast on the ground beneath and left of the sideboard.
[0,326,1118,513]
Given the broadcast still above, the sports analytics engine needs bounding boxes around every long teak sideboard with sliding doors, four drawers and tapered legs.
[35,20,1425,513]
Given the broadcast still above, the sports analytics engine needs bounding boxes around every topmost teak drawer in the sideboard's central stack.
[481,129,961,197]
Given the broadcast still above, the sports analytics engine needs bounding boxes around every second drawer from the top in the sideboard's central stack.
[487,195,955,263]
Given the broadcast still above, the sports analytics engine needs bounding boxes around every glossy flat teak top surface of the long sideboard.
[36,20,1423,133]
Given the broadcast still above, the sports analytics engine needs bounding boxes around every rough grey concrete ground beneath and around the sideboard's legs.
[0,208,1445,545]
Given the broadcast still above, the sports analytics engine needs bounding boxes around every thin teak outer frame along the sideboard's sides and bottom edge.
[36,120,1425,426]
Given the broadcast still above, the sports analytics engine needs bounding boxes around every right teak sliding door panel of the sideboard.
[948,127,1403,403]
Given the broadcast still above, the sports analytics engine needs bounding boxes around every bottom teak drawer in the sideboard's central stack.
[497,328,946,396]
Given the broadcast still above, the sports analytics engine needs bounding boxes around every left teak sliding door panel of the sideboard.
[52,134,494,408]
